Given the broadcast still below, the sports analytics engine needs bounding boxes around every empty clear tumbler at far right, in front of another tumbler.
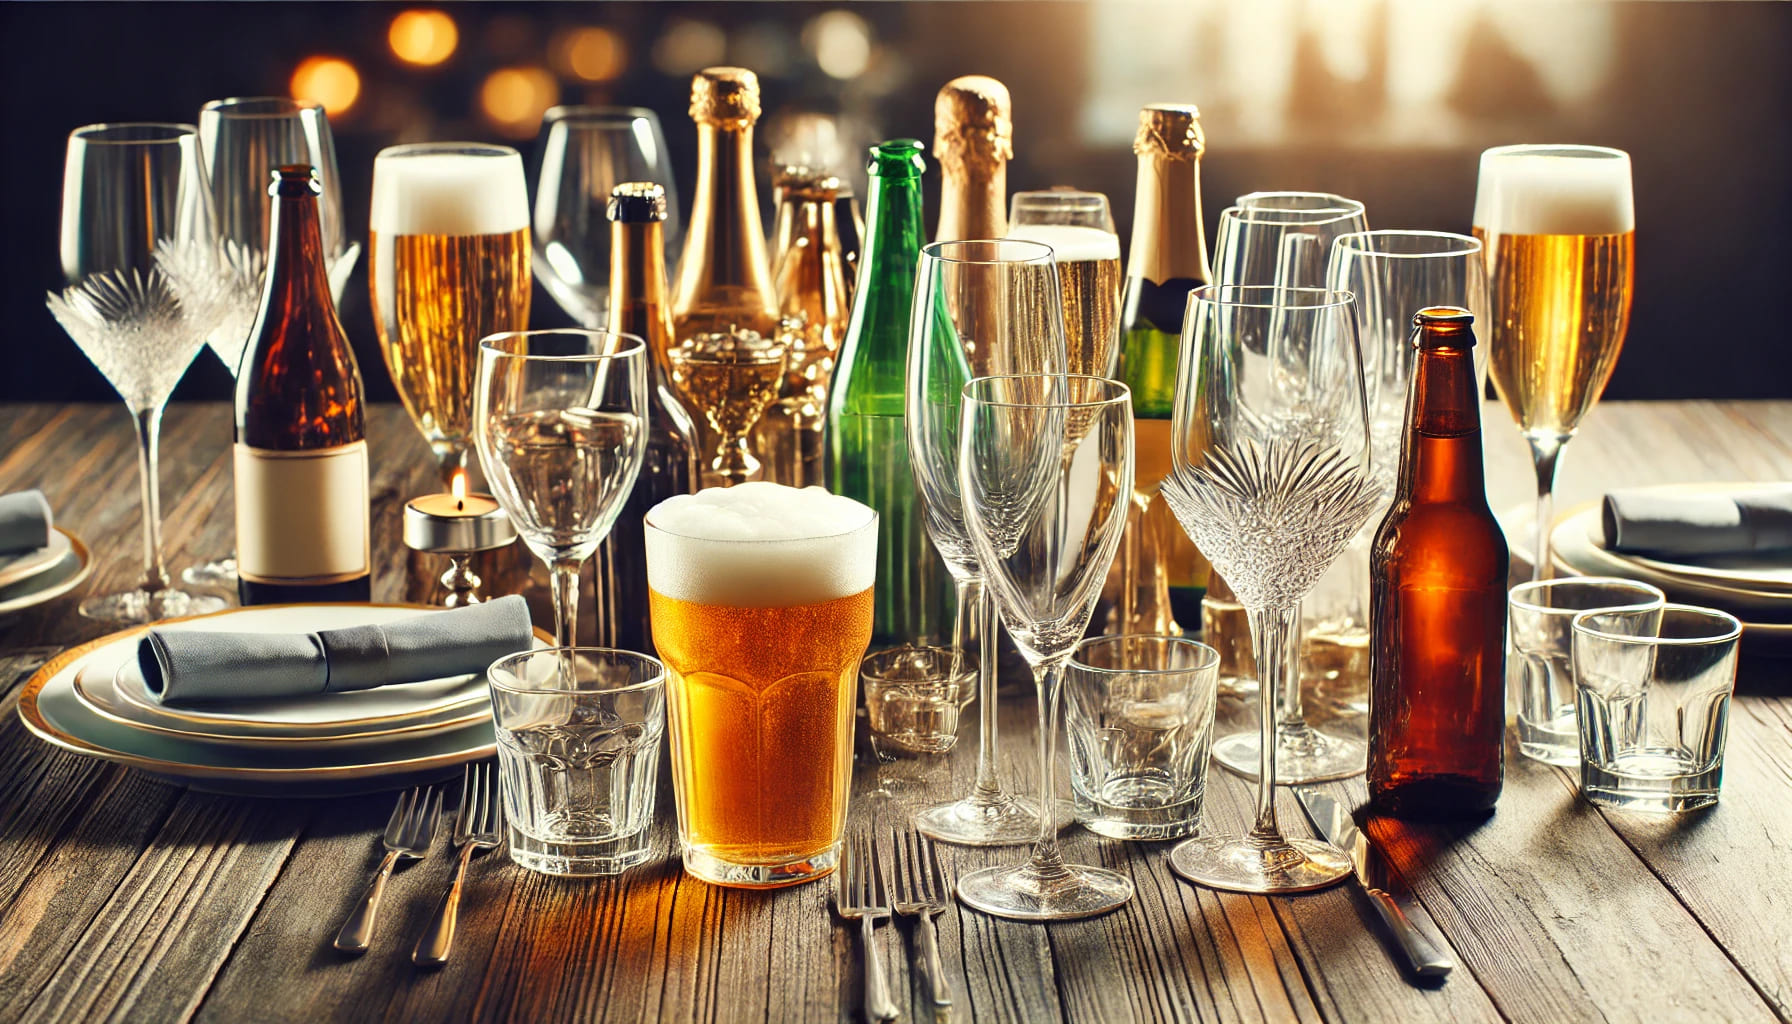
[1573,604,1742,811]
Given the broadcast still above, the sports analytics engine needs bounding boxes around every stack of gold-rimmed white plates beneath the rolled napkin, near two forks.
[20,604,539,794]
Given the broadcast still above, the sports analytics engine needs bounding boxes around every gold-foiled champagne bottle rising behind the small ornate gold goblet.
[672,68,780,482]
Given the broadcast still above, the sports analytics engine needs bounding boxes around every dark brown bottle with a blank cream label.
[233,165,373,604]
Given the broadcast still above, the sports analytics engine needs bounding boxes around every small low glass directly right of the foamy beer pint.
[858,646,977,757]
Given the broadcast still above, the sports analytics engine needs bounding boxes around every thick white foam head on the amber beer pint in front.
[647,481,878,608]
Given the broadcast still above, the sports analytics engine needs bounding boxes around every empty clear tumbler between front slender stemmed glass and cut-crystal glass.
[1064,635,1220,839]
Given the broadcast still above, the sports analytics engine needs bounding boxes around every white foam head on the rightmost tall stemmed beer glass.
[1475,145,1636,235]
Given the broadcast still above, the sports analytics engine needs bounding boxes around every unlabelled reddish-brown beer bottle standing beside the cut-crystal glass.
[1369,307,1507,818]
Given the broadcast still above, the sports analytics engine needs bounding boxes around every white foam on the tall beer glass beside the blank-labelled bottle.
[371,143,529,235]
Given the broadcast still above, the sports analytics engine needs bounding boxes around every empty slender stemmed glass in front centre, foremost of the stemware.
[959,373,1133,920]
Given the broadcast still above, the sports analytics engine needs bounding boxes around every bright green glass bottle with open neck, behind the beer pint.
[828,138,953,646]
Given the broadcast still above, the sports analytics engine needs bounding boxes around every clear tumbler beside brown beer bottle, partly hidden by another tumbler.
[1505,576,1667,768]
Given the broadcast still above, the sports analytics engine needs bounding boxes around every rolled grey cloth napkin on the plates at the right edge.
[1604,488,1792,558]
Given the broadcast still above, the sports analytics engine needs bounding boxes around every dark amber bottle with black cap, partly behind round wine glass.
[593,181,697,653]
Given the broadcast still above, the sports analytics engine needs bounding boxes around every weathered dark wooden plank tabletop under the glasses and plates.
[0,402,1792,1022]
